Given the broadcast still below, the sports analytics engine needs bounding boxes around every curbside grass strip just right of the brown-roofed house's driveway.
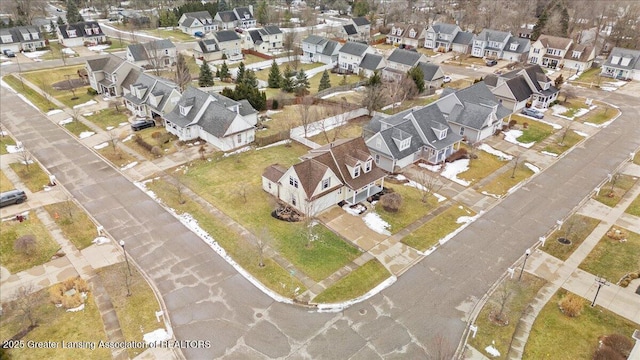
[402,205,476,251]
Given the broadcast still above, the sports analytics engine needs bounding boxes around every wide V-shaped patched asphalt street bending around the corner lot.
[0,76,640,359]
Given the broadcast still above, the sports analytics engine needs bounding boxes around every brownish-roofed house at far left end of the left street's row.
[85,54,142,96]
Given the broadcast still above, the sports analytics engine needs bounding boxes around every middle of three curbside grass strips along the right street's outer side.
[542,214,600,261]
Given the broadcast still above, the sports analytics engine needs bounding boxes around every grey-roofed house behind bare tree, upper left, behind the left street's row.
[125,39,178,69]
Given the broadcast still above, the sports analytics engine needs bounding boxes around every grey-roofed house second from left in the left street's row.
[122,73,182,121]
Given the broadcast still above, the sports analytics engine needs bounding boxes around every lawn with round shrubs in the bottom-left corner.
[0,289,111,360]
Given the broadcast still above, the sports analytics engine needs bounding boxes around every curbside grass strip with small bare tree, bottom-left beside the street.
[96,262,164,359]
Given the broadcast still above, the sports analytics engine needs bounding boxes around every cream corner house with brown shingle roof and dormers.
[262,138,385,216]
